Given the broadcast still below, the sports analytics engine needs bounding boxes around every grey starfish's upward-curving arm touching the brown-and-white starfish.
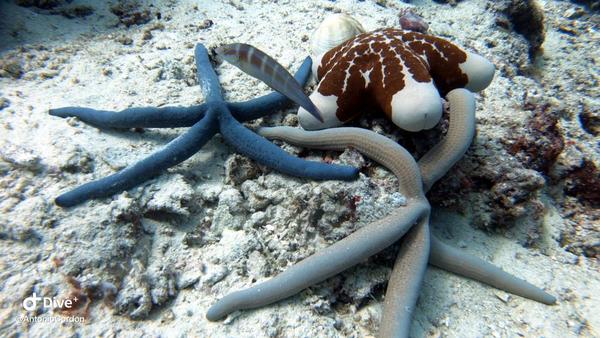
[418,88,475,191]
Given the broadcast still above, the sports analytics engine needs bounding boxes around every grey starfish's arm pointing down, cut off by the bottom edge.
[378,217,430,338]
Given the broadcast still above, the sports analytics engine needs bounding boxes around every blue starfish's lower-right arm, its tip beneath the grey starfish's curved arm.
[219,109,358,180]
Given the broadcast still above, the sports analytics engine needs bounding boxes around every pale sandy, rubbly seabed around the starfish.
[0,0,600,337]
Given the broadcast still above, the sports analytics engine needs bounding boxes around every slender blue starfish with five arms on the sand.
[50,44,358,207]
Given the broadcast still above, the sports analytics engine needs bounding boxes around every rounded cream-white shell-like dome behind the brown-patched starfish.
[310,14,365,56]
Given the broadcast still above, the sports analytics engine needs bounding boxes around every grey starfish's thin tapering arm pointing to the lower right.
[429,236,556,305]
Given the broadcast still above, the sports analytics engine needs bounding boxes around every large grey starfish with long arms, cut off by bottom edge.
[206,89,556,337]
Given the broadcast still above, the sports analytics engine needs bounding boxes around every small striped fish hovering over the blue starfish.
[216,43,323,122]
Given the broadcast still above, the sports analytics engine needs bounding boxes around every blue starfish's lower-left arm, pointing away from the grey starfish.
[55,110,218,207]
